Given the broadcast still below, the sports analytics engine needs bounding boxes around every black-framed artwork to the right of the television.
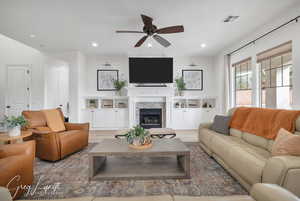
[182,69,203,91]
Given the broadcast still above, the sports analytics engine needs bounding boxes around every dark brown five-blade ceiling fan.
[116,15,184,47]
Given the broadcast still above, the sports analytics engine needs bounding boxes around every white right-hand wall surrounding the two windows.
[214,6,300,112]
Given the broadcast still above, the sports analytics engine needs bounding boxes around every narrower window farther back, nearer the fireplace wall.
[233,58,252,107]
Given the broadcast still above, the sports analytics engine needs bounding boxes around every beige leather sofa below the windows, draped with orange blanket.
[199,109,300,196]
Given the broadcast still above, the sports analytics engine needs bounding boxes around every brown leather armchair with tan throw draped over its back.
[22,109,89,161]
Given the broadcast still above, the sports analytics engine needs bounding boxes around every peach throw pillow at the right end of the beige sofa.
[272,128,300,156]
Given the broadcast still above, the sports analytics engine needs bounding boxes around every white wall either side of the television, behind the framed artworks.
[83,56,216,96]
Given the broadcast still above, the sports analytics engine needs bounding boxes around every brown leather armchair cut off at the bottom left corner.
[0,140,35,199]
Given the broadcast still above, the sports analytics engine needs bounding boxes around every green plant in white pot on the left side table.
[4,115,27,137]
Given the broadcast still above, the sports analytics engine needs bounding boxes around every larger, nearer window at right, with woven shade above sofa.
[257,42,293,109]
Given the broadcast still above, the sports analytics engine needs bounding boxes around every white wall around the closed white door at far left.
[0,34,47,119]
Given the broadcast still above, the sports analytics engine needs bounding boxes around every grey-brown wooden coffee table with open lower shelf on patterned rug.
[88,138,190,180]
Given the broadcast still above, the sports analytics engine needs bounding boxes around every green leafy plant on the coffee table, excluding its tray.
[125,126,151,145]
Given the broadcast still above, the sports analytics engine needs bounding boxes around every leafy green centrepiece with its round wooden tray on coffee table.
[125,126,152,149]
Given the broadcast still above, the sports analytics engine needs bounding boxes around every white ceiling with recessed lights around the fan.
[0,0,299,56]
